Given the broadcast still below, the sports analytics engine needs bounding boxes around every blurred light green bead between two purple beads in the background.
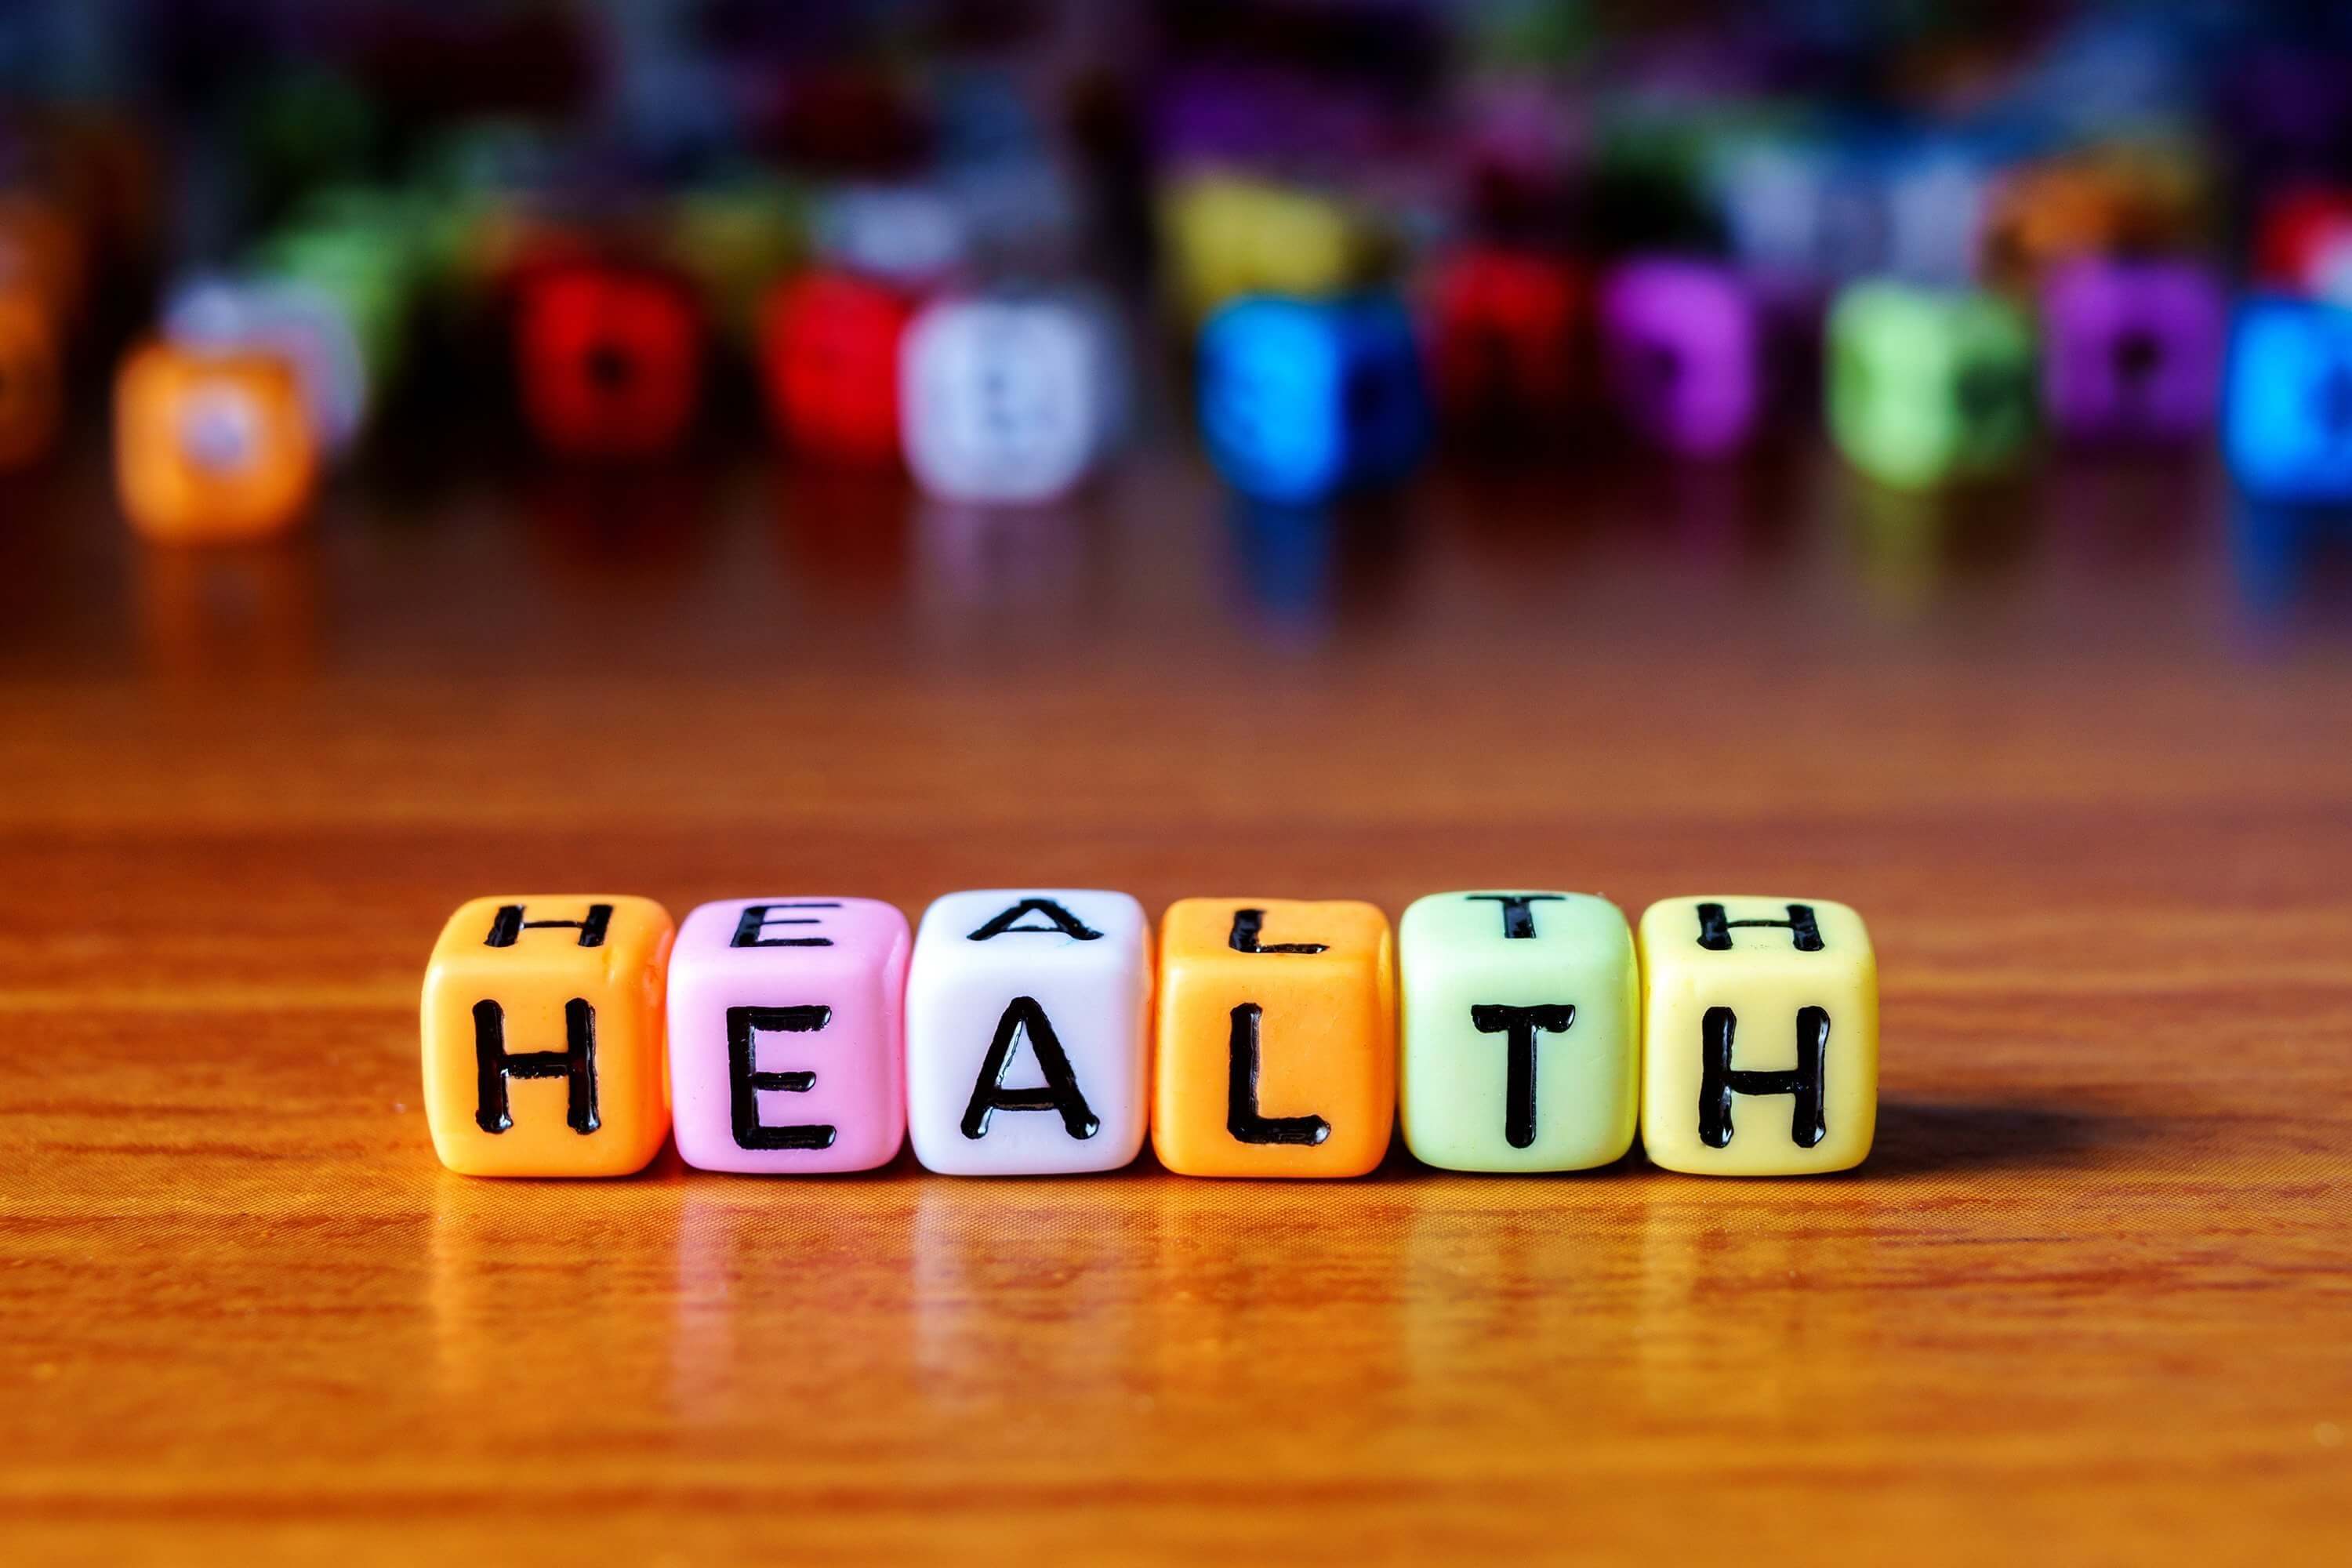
[1828,282,2034,489]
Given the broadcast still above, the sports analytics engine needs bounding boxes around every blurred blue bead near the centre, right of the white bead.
[1200,296,1430,503]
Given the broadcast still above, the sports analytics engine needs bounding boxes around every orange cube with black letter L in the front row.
[1152,898,1397,1178]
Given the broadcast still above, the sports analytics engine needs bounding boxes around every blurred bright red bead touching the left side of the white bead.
[760,270,915,463]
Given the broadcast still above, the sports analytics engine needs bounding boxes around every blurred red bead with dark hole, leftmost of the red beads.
[515,263,703,459]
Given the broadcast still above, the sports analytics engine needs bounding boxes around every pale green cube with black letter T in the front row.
[1397,888,1642,1171]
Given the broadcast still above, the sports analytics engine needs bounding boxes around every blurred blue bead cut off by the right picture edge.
[2223,299,2352,501]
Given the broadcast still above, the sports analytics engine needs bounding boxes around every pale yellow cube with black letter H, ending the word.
[1637,895,1879,1175]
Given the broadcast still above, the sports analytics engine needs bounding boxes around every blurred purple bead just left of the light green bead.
[1599,261,1764,456]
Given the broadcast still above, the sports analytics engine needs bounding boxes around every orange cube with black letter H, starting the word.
[423,893,675,1175]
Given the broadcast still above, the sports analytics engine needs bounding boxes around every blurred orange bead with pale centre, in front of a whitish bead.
[115,343,318,541]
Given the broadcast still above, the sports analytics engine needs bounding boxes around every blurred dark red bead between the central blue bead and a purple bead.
[1428,247,1588,430]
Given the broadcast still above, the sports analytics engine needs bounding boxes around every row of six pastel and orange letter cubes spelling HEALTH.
[423,888,1877,1178]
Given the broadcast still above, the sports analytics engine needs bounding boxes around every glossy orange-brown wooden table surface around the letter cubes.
[0,434,2352,1566]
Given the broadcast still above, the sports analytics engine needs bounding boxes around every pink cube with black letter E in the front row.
[670,898,913,1175]
